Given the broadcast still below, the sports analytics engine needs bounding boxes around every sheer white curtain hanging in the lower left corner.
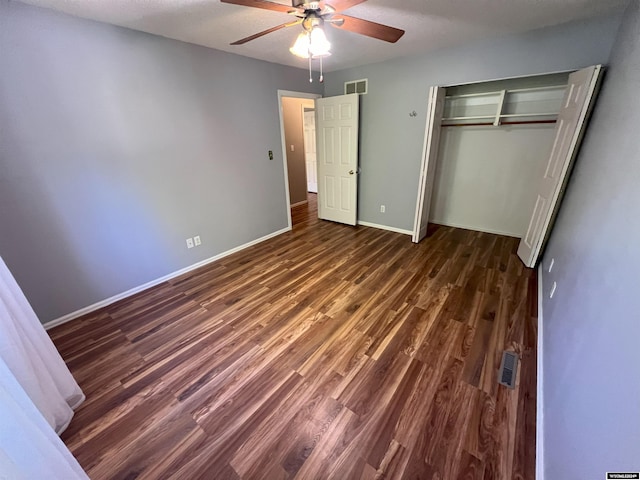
[0,257,88,480]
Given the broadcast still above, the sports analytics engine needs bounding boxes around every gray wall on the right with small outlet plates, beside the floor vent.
[543,1,640,480]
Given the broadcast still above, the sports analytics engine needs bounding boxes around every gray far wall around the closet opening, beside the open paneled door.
[325,16,620,230]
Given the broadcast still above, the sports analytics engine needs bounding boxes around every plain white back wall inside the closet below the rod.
[429,125,555,237]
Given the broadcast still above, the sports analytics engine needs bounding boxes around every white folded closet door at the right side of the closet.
[518,65,602,268]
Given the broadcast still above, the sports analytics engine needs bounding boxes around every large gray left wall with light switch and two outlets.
[0,0,321,322]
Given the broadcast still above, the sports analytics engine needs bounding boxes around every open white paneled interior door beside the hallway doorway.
[316,93,359,229]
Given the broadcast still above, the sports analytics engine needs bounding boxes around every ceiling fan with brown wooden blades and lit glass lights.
[220,0,404,54]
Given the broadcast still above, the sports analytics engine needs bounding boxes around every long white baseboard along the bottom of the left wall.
[43,227,291,330]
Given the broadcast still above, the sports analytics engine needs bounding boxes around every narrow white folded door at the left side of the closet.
[412,87,445,243]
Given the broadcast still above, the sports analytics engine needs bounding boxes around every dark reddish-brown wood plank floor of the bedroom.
[50,195,537,480]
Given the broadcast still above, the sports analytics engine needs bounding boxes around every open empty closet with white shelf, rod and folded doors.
[413,66,601,264]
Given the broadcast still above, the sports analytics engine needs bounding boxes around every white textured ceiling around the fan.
[16,0,628,71]
